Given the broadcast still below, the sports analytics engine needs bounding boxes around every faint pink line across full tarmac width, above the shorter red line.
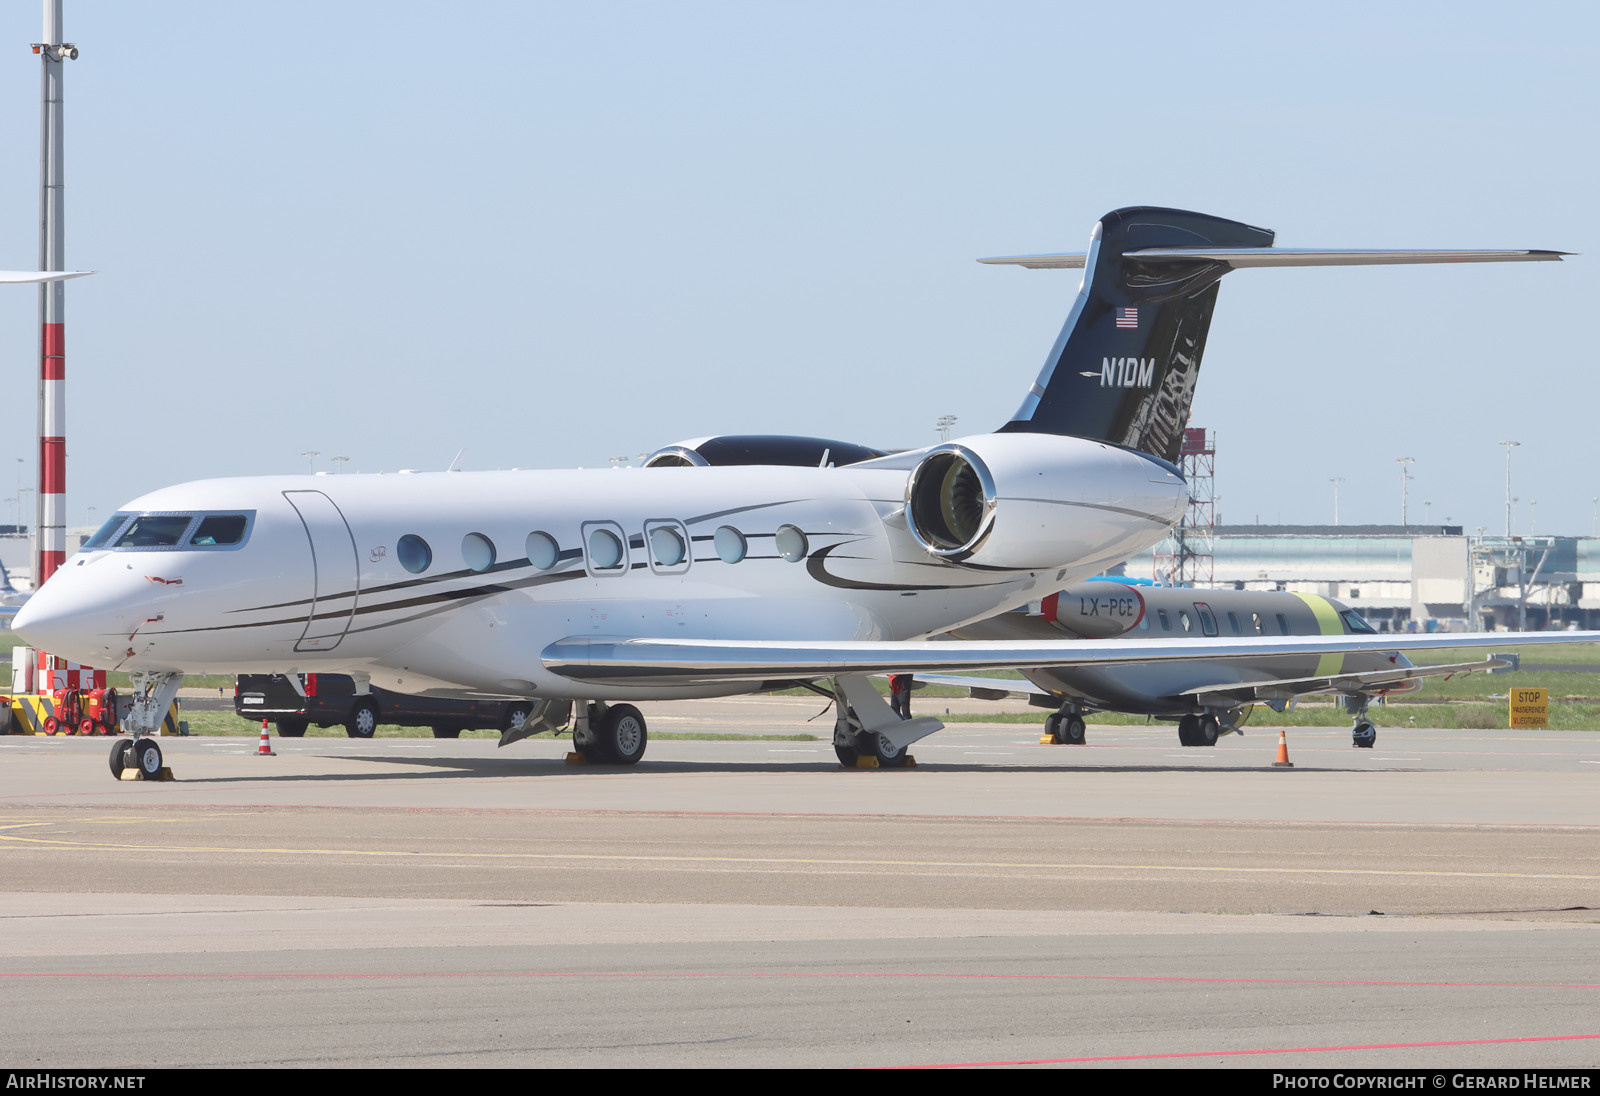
[9,971,1600,985]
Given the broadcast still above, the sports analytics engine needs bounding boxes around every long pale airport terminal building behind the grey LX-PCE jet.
[1120,525,1600,632]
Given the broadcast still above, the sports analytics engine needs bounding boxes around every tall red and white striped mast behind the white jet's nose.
[34,0,78,590]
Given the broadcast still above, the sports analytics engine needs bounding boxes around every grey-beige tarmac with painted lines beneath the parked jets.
[0,698,1600,1069]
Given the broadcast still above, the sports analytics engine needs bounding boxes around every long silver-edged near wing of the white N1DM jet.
[541,632,1600,685]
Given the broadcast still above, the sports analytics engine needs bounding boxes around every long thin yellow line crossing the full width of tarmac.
[0,822,1600,880]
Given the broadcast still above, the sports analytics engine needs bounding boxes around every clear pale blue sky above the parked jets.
[0,0,1600,533]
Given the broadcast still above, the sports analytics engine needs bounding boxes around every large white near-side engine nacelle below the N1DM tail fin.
[906,434,1189,571]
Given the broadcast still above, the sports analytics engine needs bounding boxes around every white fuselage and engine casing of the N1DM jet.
[18,435,1186,699]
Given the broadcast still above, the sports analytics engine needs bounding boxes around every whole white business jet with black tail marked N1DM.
[16,208,1592,774]
